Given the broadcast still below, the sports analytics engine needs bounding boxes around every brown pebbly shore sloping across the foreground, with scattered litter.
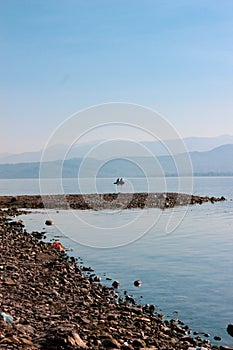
[0,210,224,350]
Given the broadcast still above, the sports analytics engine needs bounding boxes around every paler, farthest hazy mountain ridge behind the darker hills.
[0,135,233,164]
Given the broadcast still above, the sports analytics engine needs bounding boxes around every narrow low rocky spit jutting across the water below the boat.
[0,192,225,210]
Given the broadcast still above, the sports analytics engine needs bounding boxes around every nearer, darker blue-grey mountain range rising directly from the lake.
[0,144,233,179]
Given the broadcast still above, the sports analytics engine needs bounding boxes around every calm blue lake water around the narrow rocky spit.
[0,177,233,345]
